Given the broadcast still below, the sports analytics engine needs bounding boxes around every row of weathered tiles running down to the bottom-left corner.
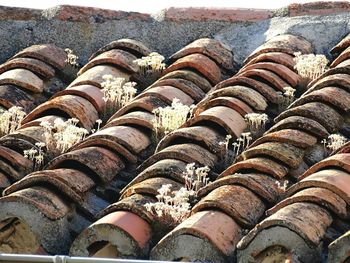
[0,40,227,254]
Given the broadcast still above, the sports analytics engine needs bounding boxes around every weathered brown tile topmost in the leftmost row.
[14,44,67,70]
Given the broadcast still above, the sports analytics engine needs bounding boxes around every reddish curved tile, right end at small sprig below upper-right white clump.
[237,69,290,92]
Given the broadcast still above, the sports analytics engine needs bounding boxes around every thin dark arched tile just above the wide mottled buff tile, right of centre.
[210,76,281,104]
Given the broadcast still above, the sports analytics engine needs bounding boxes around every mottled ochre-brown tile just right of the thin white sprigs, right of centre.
[237,142,305,169]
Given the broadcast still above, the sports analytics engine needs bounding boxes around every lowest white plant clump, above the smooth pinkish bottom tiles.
[145,163,210,228]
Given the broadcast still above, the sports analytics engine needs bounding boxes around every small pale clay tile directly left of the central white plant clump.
[103,111,155,130]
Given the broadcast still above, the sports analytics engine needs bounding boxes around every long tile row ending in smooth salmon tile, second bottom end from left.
[71,35,311,260]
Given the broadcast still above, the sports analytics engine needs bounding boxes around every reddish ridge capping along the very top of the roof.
[0,1,350,23]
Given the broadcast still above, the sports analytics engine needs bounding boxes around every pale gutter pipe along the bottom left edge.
[0,254,170,263]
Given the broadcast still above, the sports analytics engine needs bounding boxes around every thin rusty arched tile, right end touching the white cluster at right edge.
[266,116,329,139]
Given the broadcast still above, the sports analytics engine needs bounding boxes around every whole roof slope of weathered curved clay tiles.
[0,1,350,262]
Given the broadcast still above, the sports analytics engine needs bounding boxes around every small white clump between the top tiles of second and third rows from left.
[134,52,165,76]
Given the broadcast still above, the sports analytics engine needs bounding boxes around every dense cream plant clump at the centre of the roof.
[153,98,194,142]
